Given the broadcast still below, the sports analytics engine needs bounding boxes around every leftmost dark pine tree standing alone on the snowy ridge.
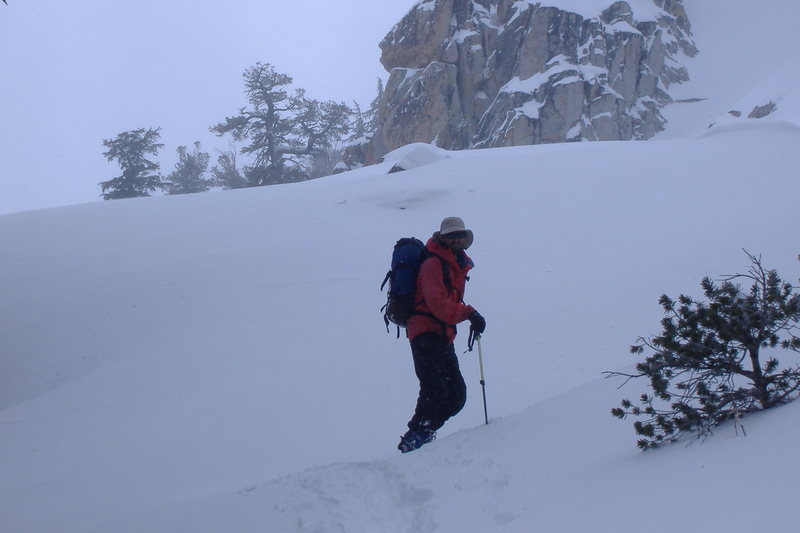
[100,128,164,200]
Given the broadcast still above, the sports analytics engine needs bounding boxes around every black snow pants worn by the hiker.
[408,333,467,431]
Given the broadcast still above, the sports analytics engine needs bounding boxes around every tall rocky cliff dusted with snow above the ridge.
[351,0,697,164]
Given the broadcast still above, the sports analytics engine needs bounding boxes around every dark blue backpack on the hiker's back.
[381,237,451,338]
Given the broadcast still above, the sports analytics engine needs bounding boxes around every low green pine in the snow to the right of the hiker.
[606,252,800,449]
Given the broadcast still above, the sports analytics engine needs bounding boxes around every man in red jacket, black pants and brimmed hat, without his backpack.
[397,217,486,453]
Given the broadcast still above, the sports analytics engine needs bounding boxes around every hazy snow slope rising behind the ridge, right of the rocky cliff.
[657,0,800,139]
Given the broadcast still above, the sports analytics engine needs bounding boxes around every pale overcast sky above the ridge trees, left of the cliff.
[0,0,417,214]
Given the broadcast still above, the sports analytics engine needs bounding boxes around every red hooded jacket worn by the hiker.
[406,234,475,342]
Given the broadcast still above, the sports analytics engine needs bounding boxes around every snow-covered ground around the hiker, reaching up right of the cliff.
[0,0,800,533]
